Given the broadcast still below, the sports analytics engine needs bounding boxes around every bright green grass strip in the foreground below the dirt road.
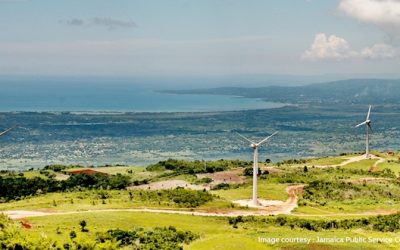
[19,212,400,250]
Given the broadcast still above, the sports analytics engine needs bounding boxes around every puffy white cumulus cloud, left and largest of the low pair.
[302,33,357,61]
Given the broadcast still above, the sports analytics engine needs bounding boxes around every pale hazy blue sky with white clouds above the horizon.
[0,0,400,77]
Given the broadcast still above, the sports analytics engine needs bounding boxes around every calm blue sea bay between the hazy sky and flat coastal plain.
[0,80,284,112]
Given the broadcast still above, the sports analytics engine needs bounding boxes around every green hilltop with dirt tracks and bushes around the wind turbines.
[0,152,400,249]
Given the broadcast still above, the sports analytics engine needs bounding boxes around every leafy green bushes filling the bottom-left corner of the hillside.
[0,215,199,250]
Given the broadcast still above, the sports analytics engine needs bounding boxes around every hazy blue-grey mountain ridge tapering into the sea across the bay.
[163,79,400,104]
